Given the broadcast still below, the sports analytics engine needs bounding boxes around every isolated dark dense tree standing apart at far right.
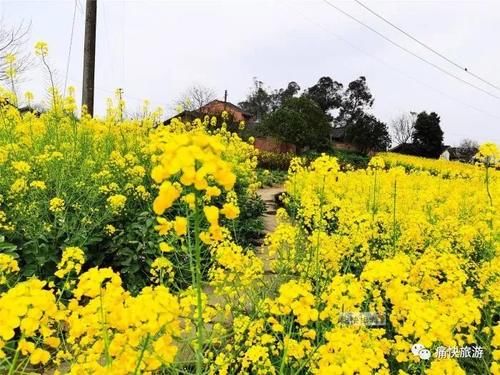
[412,111,443,158]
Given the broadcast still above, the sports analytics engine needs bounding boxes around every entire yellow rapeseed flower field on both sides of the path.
[0,50,500,375]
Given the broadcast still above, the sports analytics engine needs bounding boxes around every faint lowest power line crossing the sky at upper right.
[278,1,500,120]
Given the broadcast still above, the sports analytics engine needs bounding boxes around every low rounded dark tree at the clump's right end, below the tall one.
[345,114,391,153]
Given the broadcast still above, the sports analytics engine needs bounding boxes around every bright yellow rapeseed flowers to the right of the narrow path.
[258,151,500,374]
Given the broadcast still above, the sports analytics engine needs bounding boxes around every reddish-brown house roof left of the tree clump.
[163,100,253,125]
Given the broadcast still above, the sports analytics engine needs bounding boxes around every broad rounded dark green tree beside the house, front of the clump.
[263,96,330,150]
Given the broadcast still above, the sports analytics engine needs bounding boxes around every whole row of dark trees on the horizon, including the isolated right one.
[239,76,458,158]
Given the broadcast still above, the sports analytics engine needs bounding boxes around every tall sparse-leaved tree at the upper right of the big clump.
[337,76,375,125]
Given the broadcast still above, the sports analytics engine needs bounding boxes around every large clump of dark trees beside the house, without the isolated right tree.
[239,77,391,152]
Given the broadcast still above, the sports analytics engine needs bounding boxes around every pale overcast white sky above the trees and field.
[0,0,500,144]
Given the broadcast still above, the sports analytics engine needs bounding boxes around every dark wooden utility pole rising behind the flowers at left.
[82,0,97,116]
